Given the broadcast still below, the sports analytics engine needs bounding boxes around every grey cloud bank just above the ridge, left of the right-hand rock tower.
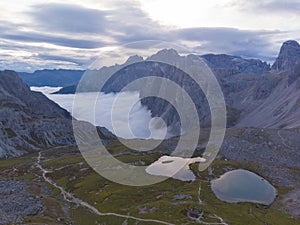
[175,27,281,58]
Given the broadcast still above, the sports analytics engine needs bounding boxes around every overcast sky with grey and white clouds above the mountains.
[0,0,300,71]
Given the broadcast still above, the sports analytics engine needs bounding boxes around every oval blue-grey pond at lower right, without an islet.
[211,169,276,205]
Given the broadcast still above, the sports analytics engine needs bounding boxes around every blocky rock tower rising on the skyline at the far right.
[272,41,300,71]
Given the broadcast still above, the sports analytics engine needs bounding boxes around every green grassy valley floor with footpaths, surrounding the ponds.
[0,140,300,225]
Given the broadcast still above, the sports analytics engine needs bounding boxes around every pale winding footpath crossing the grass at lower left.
[36,152,174,225]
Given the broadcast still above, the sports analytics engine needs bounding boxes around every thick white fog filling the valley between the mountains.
[31,87,168,139]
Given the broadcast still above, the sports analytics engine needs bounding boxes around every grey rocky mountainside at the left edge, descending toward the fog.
[0,71,110,158]
